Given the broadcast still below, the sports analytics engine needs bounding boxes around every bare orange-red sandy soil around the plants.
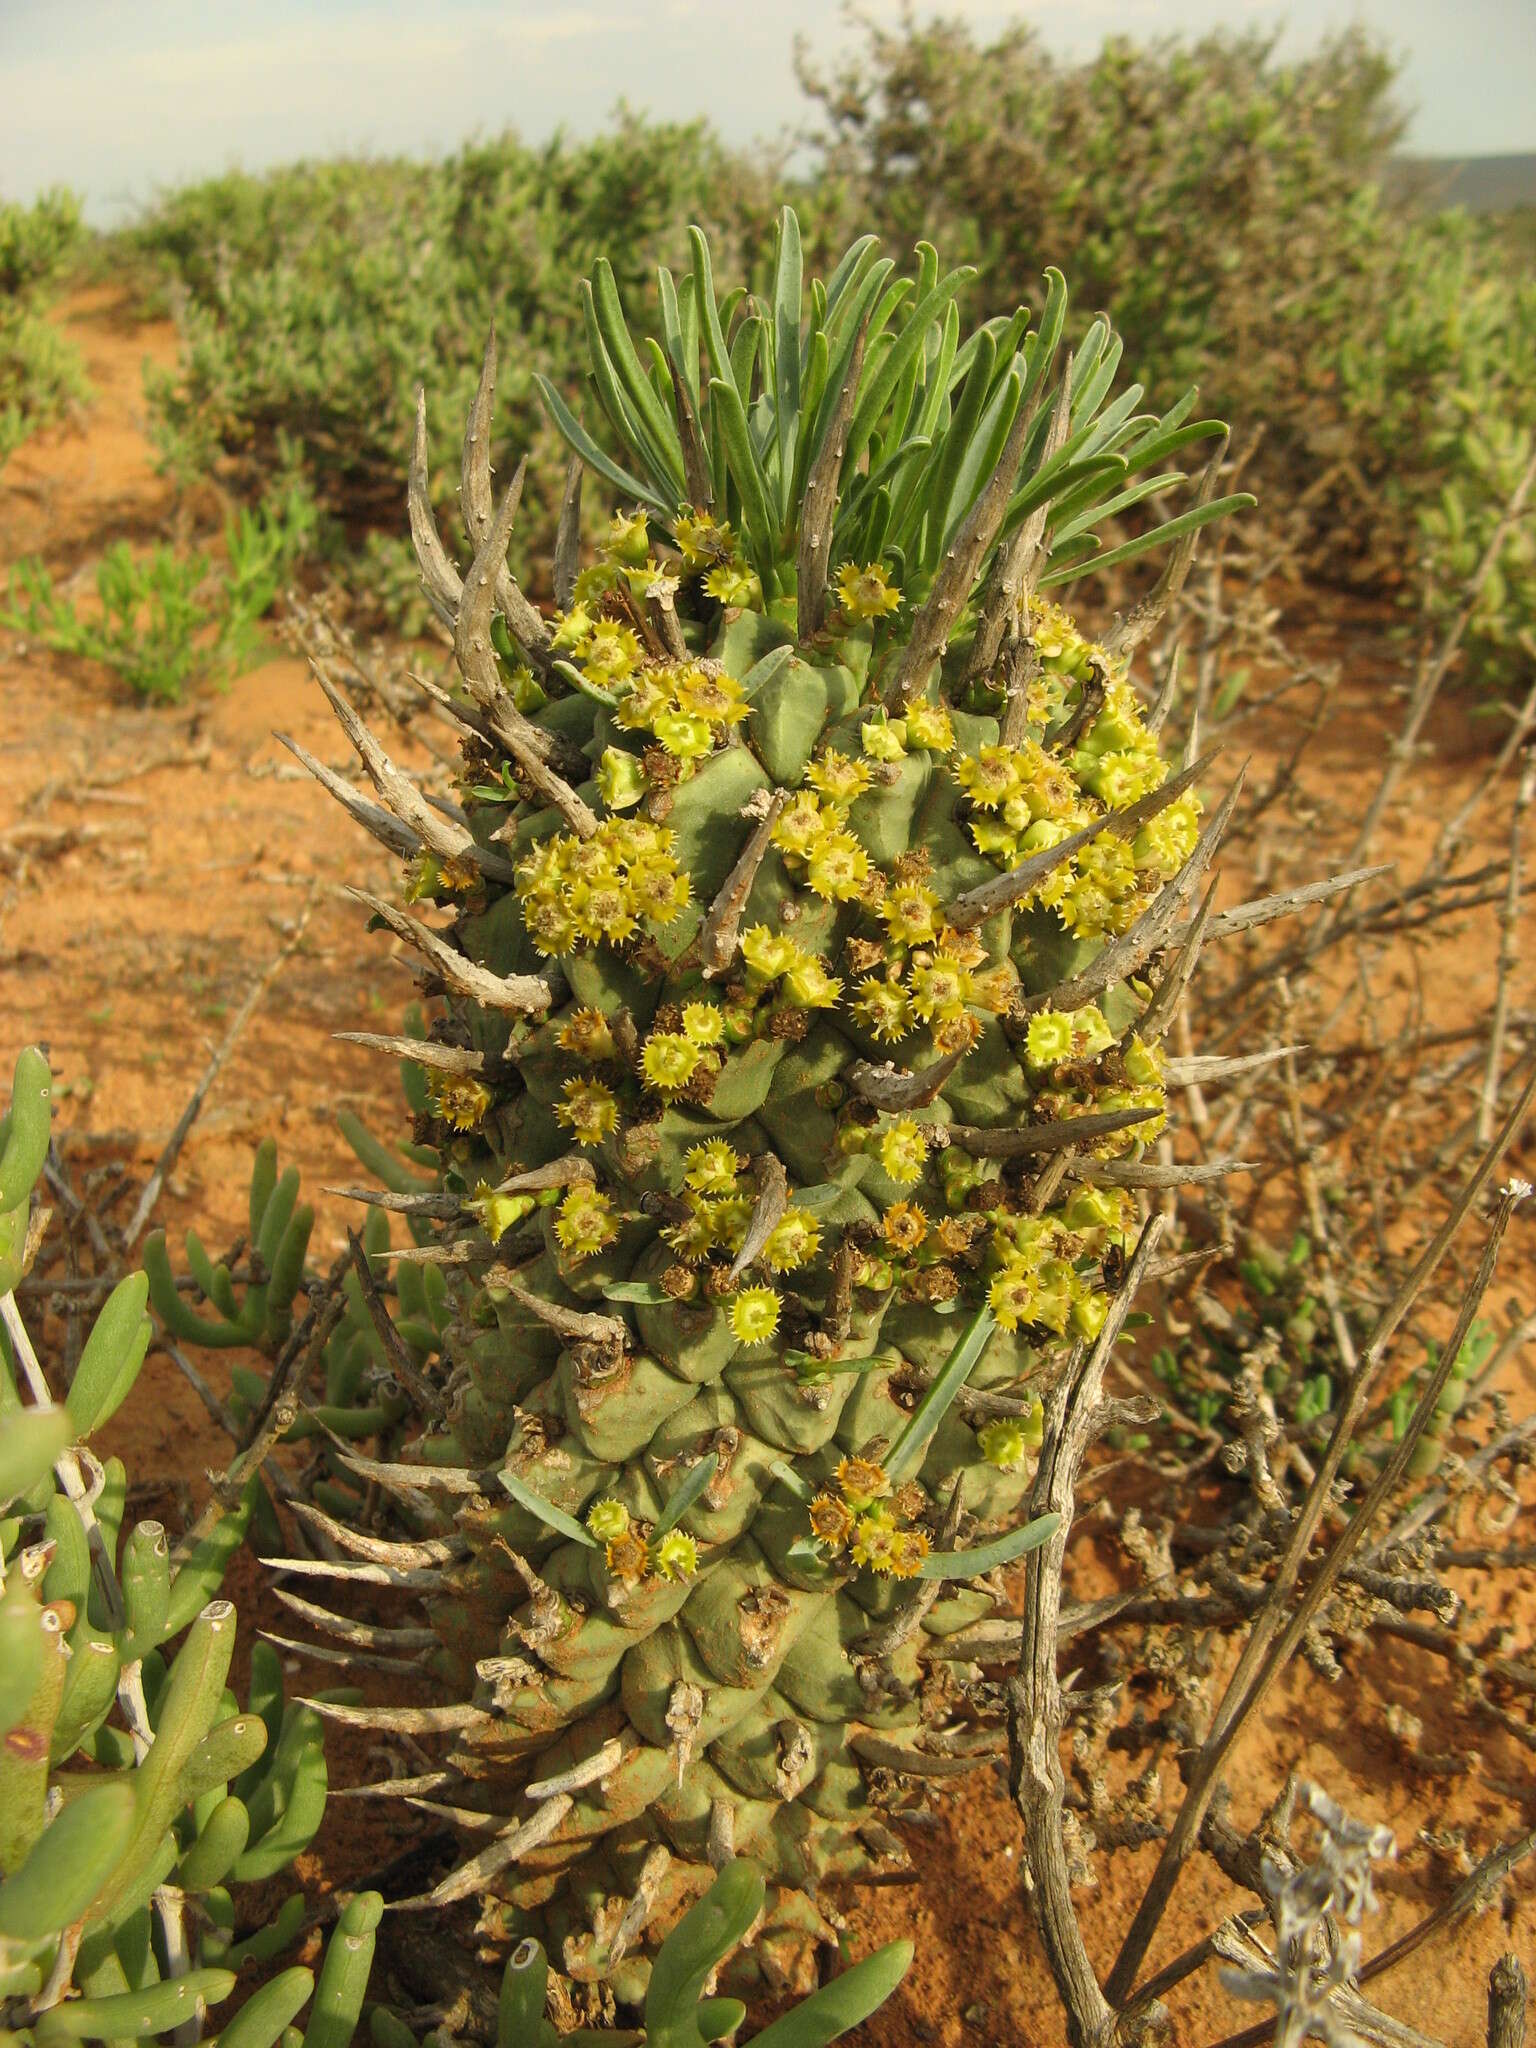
[0,291,1536,2048]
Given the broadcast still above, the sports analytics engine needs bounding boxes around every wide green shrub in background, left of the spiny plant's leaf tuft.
[131,119,772,614]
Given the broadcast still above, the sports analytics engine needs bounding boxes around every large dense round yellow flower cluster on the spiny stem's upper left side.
[516,817,688,956]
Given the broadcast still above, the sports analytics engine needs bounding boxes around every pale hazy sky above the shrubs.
[0,0,1536,223]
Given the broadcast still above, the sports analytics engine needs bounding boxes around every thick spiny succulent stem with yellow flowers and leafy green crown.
[286,211,1245,1999]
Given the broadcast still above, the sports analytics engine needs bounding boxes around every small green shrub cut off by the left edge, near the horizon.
[0,190,86,465]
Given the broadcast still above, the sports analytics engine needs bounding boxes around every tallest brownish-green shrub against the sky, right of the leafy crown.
[803,20,1401,483]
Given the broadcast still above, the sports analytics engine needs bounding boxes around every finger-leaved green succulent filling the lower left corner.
[0,1047,331,2048]
